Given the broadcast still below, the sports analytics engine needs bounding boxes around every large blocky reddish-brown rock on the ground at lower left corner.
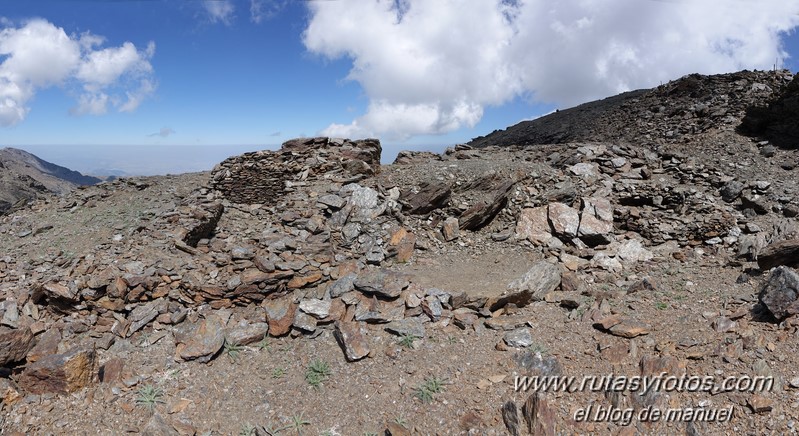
[19,348,95,394]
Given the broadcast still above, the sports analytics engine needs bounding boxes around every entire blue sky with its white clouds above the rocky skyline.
[0,0,799,174]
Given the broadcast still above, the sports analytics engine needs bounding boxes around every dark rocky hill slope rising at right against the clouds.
[469,70,793,147]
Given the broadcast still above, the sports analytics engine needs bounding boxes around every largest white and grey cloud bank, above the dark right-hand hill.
[303,0,799,139]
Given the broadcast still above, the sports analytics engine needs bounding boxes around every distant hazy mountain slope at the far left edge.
[0,147,101,214]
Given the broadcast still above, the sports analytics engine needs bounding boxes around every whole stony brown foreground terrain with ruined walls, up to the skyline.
[0,72,799,435]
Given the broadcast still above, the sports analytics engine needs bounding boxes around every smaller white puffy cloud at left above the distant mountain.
[0,19,155,127]
